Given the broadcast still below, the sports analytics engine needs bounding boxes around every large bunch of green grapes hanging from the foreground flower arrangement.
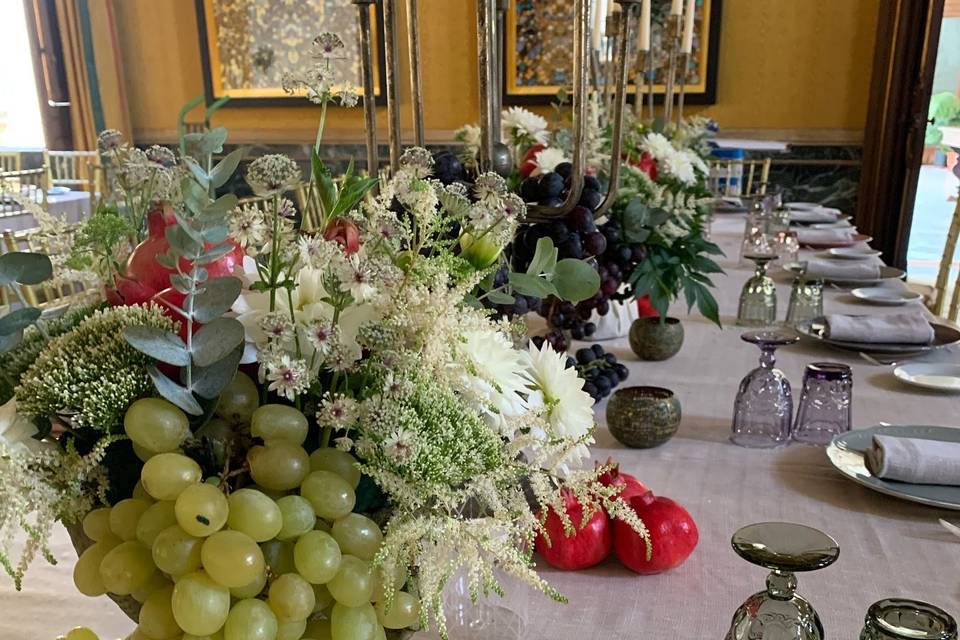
[74,374,419,640]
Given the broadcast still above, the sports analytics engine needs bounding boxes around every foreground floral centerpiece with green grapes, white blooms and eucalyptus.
[0,34,649,640]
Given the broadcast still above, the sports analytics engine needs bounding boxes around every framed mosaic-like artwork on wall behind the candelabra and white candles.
[503,0,722,104]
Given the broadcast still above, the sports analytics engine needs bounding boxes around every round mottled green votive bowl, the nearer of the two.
[607,387,680,449]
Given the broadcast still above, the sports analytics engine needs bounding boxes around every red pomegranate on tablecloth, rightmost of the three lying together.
[613,492,700,575]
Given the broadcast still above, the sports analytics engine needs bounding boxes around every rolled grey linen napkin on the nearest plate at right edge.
[864,435,960,485]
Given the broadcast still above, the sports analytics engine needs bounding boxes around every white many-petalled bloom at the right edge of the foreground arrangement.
[526,342,593,455]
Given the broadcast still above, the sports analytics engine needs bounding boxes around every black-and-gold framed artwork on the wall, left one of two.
[196,0,386,106]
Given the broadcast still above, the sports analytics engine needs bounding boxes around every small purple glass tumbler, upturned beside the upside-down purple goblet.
[793,362,853,445]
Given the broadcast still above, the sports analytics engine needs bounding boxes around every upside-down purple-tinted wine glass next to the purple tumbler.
[730,330,800,448]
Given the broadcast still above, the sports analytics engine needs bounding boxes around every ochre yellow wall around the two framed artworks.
[114,0,881,142]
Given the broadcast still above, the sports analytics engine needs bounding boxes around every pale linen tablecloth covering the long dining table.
[0,215,960,640]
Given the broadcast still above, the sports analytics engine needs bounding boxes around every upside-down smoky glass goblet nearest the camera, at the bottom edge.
[726,522,840,640]
